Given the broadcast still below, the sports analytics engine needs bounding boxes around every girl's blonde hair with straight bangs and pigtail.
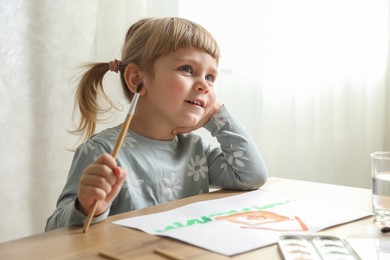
[73,17,220,141]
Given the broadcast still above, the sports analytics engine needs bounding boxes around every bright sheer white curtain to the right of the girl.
[179,0,390,188]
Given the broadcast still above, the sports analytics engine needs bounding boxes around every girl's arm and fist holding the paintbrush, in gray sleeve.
[45,140,126,231]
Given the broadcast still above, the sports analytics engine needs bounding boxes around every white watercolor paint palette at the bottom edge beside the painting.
[278,235,360,260]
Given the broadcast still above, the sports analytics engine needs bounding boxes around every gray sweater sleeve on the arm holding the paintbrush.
[45,140,109,231]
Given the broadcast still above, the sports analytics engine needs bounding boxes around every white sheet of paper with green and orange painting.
[113,190,371,256]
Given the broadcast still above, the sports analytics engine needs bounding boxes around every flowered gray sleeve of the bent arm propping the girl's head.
[205,106,267,190]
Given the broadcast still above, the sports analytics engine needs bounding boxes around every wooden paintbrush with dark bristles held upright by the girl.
[83,82,143,233]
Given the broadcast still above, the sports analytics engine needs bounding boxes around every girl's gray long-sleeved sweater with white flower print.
[45,106,267,231]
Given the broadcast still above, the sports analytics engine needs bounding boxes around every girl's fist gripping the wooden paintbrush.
[77,154,127,216]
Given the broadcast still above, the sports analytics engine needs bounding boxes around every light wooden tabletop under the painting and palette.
[0,177,381,260]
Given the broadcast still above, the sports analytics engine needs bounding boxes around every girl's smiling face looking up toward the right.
[143,48,218,131]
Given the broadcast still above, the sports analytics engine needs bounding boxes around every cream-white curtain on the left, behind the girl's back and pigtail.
[0,0,177,242]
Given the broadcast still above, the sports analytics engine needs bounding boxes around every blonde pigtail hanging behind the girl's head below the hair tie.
[72,63,113,142]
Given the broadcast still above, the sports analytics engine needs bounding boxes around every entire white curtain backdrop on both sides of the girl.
[0,0,390,242]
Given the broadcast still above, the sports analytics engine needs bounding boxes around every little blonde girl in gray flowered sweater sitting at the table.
[46,18,267,230]
